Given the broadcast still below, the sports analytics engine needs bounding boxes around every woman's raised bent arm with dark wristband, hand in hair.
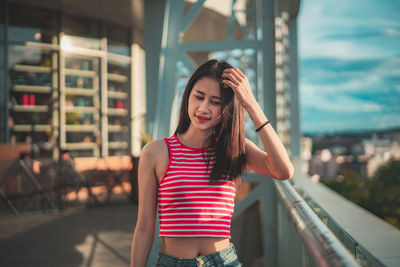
[222,68,294,180]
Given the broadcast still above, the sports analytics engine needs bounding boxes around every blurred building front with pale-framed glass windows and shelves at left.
[0,1,145,158]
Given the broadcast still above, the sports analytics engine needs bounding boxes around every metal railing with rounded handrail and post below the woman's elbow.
[234,173,359,266]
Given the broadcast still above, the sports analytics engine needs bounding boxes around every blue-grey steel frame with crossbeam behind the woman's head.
[153,0,276,139]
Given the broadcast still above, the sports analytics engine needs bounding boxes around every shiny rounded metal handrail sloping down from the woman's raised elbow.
[275,181,359,266]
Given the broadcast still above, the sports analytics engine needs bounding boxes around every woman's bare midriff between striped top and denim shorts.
[161,237,231,259]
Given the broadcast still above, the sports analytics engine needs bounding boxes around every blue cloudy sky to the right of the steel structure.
[298,0,400,133]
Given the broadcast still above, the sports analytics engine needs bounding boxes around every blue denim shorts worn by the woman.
[157,244,242,267]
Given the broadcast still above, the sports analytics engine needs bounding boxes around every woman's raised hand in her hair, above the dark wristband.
[221,68,257,110]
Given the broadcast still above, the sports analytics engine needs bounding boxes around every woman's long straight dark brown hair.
[175,59,246,182]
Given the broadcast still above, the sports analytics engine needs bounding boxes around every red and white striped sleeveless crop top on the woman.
[157,135,236,238]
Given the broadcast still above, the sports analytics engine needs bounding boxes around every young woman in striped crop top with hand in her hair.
[131,60,294,267]
